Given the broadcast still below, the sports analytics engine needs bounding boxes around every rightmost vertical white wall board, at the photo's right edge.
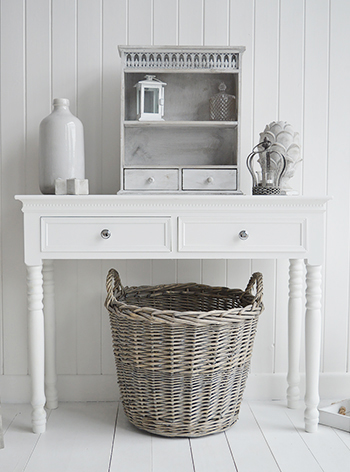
[323,0,350,372]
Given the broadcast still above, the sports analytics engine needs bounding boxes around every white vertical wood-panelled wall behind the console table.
[0,0,350,401]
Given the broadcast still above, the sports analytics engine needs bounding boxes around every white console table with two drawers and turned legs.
[16,194,328,433]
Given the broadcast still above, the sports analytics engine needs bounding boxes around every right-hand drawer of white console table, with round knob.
[178,217,306,254]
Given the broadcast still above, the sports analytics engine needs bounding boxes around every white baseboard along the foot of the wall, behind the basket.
[0,373,350,403]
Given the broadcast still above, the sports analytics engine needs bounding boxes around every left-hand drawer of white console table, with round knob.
[41,217,171,253]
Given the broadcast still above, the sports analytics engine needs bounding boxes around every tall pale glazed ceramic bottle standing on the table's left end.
[39,98,85,194]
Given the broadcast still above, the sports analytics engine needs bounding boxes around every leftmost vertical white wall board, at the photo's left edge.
[0,0,27,374]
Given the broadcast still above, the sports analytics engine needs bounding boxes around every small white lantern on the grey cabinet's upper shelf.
[135,75,166,121]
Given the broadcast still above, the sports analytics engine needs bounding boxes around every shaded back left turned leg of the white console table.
[43,260,58,410]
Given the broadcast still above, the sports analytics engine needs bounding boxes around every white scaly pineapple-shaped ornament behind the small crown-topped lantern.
[260,121,302,195]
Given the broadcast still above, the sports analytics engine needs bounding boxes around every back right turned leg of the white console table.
[287,259,304,408]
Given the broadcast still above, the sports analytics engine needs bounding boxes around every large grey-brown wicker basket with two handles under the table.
[105,269,263,437]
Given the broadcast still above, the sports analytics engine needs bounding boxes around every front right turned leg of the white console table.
[304,262,322,433]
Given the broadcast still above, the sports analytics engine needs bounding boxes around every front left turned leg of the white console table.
[27,265,46,433]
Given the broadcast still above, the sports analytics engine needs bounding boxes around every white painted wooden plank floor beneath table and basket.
[0,401,350,472]
